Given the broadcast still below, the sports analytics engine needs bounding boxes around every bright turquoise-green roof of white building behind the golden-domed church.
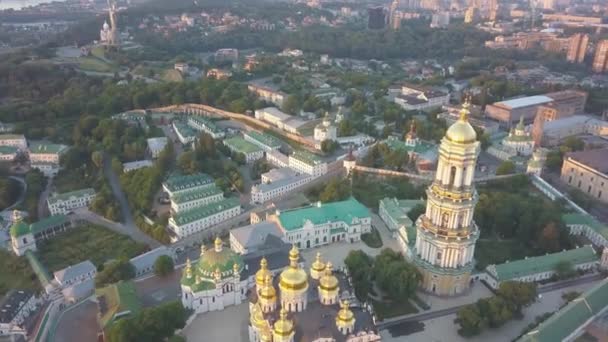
[279,197,370,230]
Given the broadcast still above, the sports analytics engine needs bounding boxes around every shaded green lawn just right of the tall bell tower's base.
[475,239,532,270]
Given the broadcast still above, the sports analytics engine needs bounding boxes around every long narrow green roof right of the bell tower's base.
[488,246,599,281]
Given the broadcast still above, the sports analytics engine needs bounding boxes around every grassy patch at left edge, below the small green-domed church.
[0,249,40,297]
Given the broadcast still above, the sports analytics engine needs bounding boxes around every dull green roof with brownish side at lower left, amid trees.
[95,281,142,329]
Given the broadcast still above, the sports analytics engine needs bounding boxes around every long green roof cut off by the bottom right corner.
[517,279,608,342]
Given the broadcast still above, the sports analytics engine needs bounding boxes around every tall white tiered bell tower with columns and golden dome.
[412,97,480,296]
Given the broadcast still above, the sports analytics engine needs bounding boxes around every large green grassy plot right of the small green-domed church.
[37,224,147,273]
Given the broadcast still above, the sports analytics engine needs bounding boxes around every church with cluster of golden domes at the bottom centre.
[248,246,381,342]
